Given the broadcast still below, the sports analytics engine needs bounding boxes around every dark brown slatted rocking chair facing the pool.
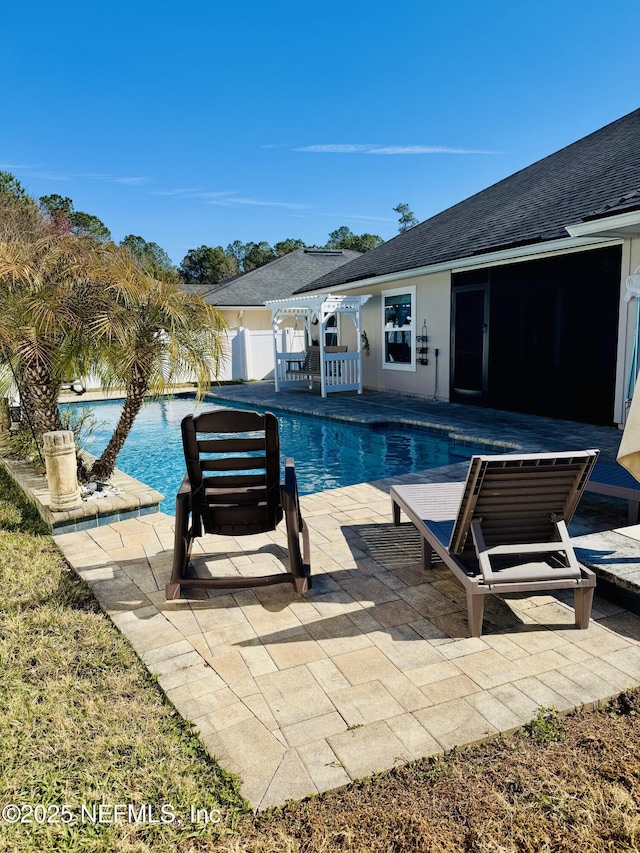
[166,409,311,599]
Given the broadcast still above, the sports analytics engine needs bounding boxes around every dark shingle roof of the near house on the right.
[298,109,640,292]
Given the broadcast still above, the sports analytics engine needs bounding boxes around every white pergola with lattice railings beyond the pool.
[265,293,371,397]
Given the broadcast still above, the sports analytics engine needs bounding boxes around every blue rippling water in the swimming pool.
[70,398,482,515]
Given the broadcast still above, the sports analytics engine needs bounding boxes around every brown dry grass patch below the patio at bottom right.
[209,691,640,853]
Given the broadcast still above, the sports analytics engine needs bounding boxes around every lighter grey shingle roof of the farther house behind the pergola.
[198,249,360,308]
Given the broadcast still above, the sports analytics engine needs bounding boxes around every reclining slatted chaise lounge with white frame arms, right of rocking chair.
[391,450,598,637]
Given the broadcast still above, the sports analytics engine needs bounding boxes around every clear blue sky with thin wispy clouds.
[0,0,640,263]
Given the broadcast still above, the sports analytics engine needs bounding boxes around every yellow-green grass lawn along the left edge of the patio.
[0,470,247,851]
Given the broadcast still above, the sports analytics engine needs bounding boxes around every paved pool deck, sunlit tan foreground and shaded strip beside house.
[56,383,640,808]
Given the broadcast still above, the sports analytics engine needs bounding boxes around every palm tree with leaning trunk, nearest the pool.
[85,245,226,480]
